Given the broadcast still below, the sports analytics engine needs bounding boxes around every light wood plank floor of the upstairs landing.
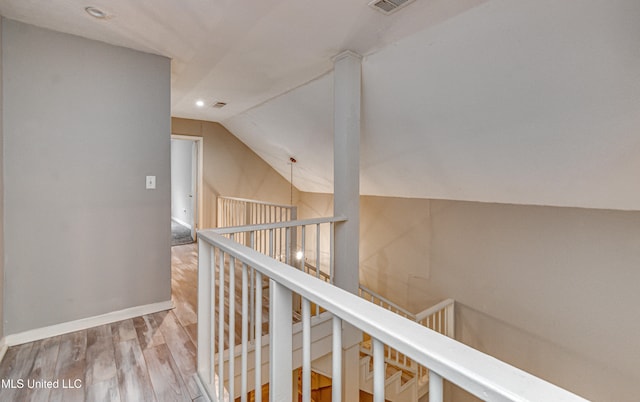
[0,244,203,402]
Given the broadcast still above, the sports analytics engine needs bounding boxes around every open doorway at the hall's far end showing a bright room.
[171,135,202,246]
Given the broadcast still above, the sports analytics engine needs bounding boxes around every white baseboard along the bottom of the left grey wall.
[0,300,175,353]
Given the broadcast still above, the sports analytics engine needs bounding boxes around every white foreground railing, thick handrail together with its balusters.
[198,226,584,402]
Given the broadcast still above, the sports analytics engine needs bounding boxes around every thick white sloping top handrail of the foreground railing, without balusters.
[198,231,585,402]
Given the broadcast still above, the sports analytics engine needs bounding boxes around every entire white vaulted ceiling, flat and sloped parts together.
[0,0,640,210]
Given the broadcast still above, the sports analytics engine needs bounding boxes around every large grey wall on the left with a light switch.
[2,20,171,334]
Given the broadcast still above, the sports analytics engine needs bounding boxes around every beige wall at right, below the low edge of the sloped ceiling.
[424,200,640,401]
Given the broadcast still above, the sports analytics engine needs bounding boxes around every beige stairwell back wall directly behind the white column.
[298,192,430,313]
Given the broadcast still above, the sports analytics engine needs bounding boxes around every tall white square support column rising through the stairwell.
[333,51,362,401]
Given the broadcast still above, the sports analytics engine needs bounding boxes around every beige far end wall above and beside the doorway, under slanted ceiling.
[171,117,298,228]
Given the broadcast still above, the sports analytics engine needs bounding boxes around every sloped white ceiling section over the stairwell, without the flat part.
[223,1,640,210]
